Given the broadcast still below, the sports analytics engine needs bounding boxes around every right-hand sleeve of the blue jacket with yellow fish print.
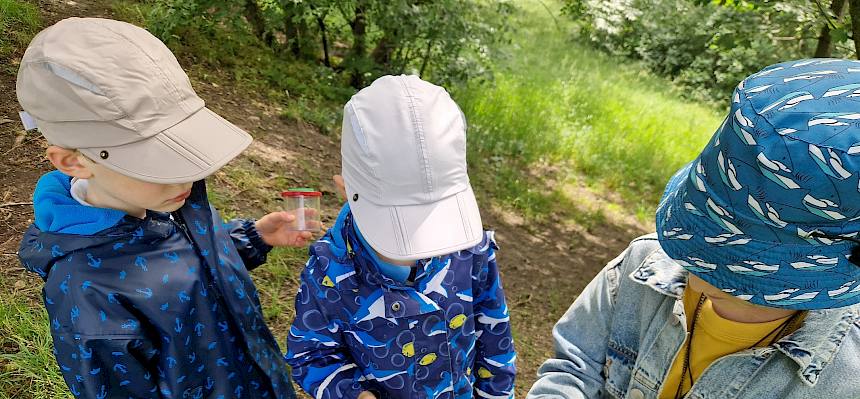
[473,245,517,399]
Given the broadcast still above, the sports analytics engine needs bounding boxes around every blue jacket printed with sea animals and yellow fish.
[287,206,516,399]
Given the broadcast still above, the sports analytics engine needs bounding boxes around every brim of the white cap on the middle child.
[349,187,483,261]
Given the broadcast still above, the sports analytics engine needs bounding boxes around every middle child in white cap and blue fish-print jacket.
[287,76,516,399]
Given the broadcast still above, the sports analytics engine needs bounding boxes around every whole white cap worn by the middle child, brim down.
[341,75,483,260]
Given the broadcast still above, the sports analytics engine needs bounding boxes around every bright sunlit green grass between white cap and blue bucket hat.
[455,2,721,220]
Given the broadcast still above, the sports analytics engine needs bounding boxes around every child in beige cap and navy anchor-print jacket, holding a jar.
[17,18,311,399]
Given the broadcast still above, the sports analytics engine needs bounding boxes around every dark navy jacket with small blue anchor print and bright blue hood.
[19,172,295,399]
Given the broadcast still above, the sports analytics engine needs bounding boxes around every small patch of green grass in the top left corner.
[0,0,42,74]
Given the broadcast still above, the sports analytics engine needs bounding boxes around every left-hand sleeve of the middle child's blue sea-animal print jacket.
[286,256,372,399]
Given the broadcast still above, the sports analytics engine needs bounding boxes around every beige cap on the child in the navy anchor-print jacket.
[16,18,252,184]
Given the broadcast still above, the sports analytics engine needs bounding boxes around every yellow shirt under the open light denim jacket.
[660,288,797,399]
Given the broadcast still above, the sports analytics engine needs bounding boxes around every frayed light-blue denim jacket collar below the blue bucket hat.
[629,249,860,386]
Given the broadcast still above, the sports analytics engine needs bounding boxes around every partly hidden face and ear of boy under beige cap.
[48,147,193,217]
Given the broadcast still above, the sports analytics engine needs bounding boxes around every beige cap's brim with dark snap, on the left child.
[80,108,253,184]
